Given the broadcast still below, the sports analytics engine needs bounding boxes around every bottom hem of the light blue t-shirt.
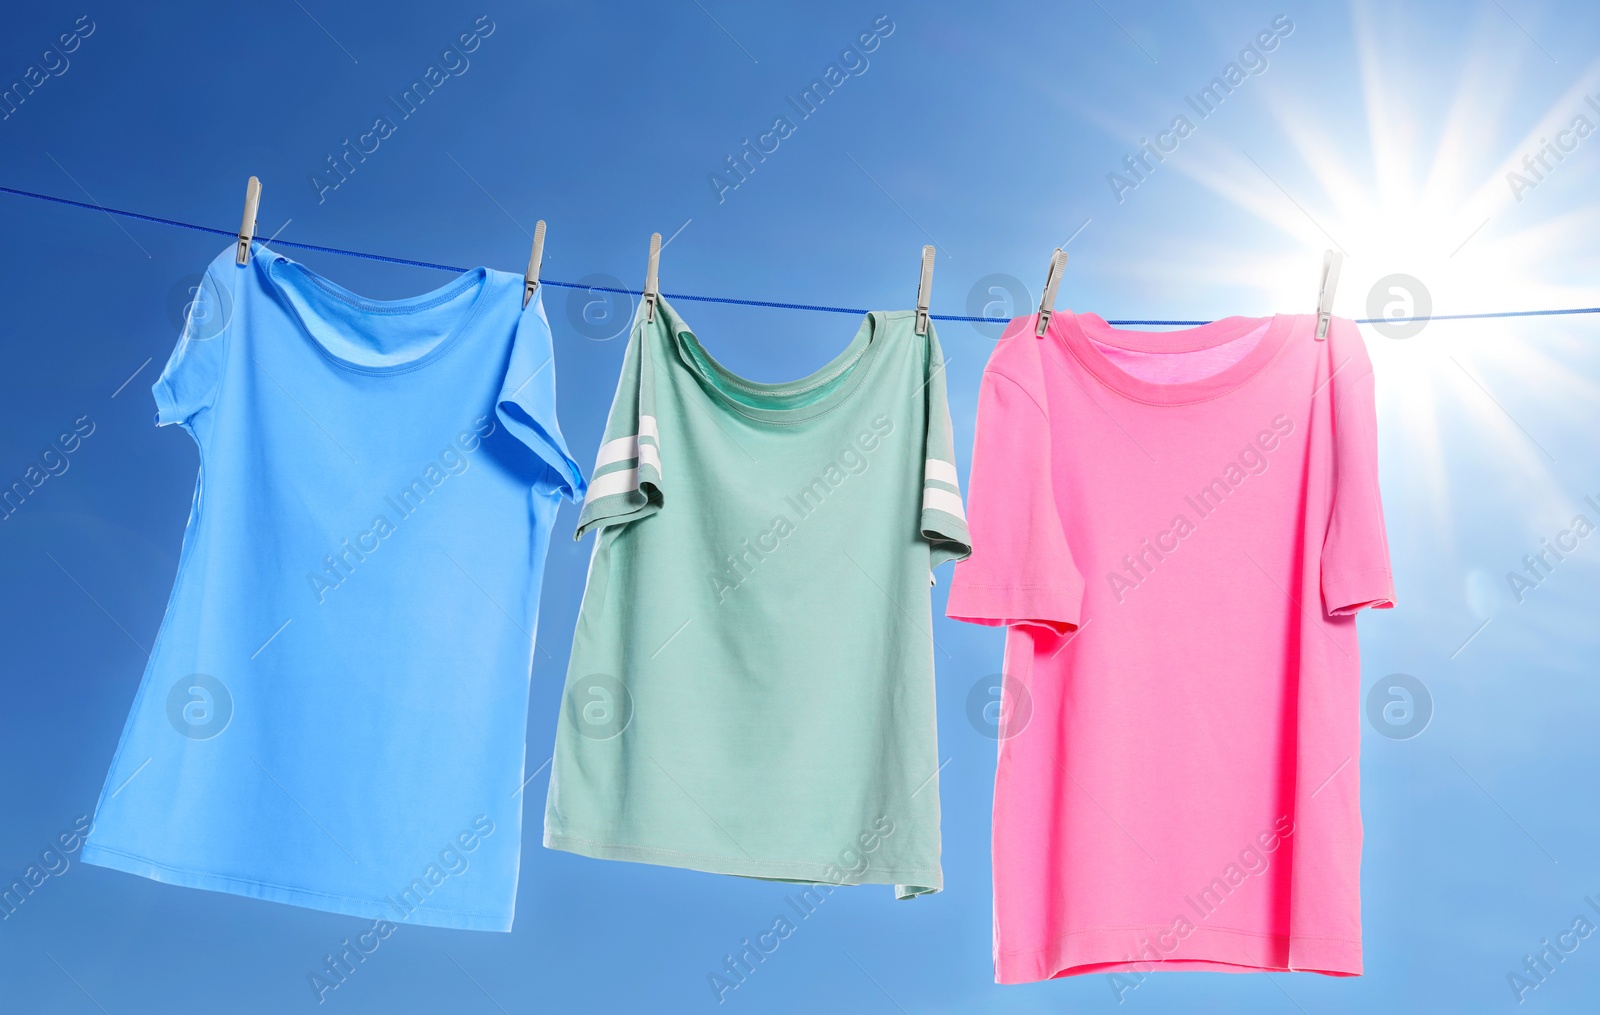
[78,842,512,933]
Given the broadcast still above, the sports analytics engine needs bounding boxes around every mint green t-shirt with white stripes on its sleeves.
[544,292,971,898]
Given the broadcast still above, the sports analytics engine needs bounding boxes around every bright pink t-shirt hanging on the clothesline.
[949,311,1394,996]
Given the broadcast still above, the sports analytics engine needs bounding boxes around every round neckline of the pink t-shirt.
[1049,311,1301,405]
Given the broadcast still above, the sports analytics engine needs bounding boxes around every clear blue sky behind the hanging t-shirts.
[0,0,1600,1012]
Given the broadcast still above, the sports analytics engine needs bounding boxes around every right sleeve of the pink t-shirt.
[1322,319,1395,616]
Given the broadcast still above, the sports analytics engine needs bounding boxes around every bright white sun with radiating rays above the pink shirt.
[1158,5,1600,544]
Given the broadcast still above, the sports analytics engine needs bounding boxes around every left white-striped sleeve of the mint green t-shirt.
[573,301,672,540]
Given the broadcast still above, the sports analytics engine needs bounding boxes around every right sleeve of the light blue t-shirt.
[494,291,584,501]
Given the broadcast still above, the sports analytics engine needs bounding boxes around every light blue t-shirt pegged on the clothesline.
[83,245,584,930]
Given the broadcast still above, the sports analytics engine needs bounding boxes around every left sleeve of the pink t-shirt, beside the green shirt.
[946,328,1083,632]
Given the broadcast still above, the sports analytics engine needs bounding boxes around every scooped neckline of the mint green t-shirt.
[656,292,912,426]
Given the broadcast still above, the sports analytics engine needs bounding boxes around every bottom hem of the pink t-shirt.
[995,924,1362,983]
